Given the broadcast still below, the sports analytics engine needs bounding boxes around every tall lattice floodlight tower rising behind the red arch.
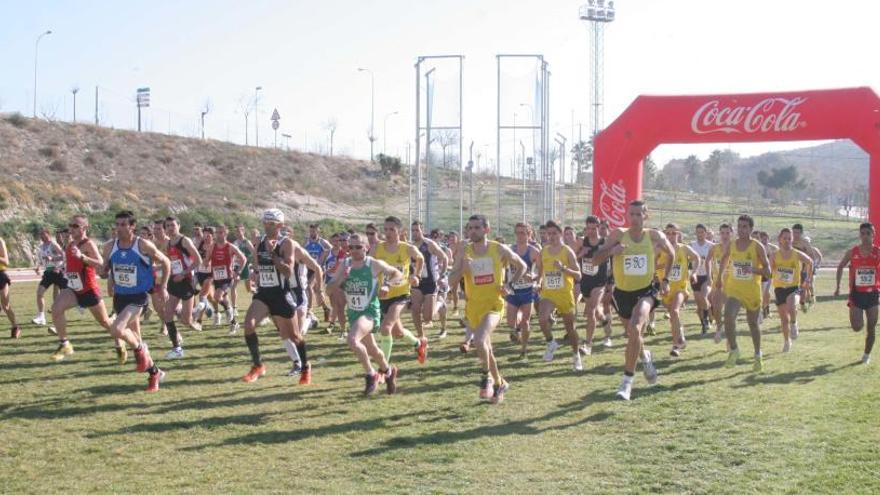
[578,0,615,136]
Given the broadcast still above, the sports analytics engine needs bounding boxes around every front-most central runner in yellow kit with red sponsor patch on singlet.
[449,215,526,404]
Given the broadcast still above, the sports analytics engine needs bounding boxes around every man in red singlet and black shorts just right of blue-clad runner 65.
[162,217,202,359]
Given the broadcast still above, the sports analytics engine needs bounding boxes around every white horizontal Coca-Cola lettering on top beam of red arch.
[691,96,807,134]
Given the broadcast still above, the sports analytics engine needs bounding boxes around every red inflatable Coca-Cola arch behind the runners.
[593,88,880,226]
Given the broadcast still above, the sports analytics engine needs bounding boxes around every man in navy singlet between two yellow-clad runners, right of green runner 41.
[410,220,449,339]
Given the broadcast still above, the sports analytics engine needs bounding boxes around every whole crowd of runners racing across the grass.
[0,201,880,403]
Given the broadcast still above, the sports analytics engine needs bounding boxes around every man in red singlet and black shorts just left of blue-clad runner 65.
[52,215,117,365]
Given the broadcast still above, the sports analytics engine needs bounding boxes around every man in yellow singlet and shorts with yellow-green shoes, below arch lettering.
[718,215,770,373]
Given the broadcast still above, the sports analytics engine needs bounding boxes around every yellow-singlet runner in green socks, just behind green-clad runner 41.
[370,216,428,363]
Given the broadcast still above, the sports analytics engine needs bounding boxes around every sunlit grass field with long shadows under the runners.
[0,274,880,494]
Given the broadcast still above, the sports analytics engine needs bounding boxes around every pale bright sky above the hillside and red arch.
[0,0,880,169]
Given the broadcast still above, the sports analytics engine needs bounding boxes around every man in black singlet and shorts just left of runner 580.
[577,215,611,356]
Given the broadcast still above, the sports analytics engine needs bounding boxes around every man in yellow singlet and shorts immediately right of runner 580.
[663,223,700,357]
